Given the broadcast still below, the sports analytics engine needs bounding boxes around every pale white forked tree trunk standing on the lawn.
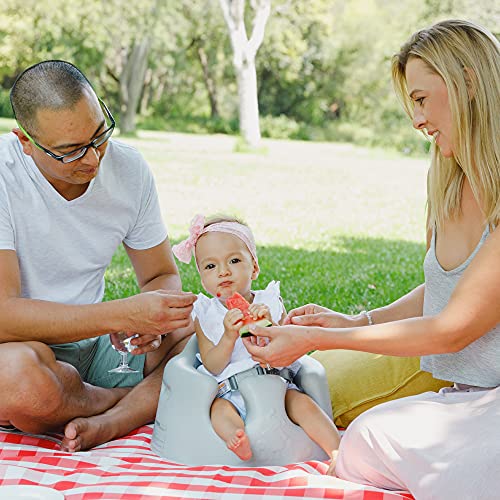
[219,0,271,147]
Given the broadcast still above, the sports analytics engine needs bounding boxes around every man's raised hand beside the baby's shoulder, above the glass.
[123,290,196,336]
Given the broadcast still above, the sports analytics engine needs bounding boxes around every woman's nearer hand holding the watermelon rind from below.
[243,325,314,366]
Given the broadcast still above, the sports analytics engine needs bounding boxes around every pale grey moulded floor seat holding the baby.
[151,336,332,467]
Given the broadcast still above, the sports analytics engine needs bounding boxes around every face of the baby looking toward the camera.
[196,231,257,302]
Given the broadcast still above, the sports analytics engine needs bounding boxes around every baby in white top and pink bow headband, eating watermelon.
[173,215,340,460]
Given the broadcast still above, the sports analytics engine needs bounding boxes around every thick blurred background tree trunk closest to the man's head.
[120,36,151,134]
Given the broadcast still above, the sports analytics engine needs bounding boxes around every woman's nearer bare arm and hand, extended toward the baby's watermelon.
[247,228,500,366]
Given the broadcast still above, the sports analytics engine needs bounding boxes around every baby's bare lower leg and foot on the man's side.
[210,398,252,460]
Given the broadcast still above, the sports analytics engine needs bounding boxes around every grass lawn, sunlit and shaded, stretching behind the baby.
[102,131,428,312]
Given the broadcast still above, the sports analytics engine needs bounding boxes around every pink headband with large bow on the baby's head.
[172,215,259,267]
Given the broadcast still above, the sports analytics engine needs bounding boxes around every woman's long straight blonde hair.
[392,20,500,229]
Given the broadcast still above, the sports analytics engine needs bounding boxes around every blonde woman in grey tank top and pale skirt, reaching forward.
[246,20,500,500]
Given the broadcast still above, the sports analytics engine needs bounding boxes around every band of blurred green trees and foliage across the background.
[0,0,500,148]
